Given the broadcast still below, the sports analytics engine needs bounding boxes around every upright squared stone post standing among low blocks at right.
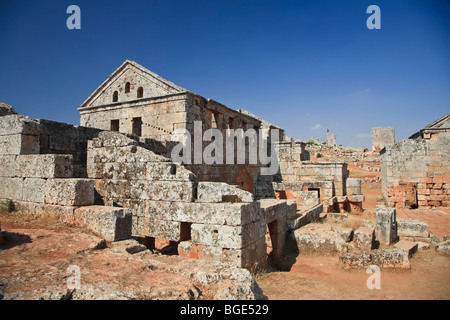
[375,206,397,245]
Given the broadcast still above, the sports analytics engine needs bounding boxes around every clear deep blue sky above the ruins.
[0,0,450,148]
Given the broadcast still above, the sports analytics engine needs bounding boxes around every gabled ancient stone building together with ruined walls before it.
[0,60,370,267]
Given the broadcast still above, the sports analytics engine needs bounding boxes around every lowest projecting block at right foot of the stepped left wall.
[74,206,132,241]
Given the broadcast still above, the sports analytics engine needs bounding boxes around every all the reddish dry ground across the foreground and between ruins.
[0,165,450,300]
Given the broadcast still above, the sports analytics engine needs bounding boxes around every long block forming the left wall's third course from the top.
[16,154,73,178]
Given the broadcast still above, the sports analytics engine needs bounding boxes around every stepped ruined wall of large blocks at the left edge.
[0,108,131,241]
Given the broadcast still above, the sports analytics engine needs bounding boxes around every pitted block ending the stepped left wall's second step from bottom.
[45,179,94,206]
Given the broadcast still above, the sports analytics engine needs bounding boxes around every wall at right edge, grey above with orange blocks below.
[381,132,450,208]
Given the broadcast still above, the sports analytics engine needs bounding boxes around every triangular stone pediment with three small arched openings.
[80,60,187,109]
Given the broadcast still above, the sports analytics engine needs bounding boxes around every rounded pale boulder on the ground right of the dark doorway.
[290,224,348,253]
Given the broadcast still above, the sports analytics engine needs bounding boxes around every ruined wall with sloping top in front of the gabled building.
[88,132,295,267]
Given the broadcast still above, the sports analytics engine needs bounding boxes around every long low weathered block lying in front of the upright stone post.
[339,248,411,269]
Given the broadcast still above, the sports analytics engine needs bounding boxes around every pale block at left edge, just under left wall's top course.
[0,134,39,155]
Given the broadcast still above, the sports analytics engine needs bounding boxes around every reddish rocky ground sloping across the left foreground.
[0,212,265,300]
